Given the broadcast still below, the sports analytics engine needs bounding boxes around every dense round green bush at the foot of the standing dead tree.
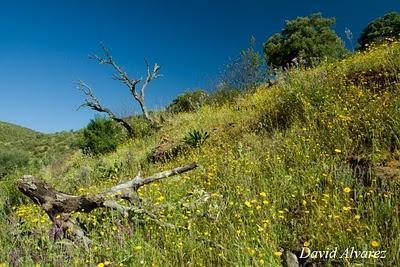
[80,117,121,155]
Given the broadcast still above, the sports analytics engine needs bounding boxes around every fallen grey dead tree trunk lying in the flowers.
[18,163,198,244]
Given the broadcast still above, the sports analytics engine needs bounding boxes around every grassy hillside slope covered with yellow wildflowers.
[0,42,400,266]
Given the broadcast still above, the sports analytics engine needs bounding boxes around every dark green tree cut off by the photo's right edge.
[358,12,400,50]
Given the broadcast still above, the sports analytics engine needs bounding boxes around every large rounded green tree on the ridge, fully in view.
[264,13,347,67]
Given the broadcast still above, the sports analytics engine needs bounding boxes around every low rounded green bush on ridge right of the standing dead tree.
[167,89,209,113]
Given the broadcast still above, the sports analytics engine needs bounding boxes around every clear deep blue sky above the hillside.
[0,0,400,132]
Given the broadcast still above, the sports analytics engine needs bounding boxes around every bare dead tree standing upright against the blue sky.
[78,44,161,134]
